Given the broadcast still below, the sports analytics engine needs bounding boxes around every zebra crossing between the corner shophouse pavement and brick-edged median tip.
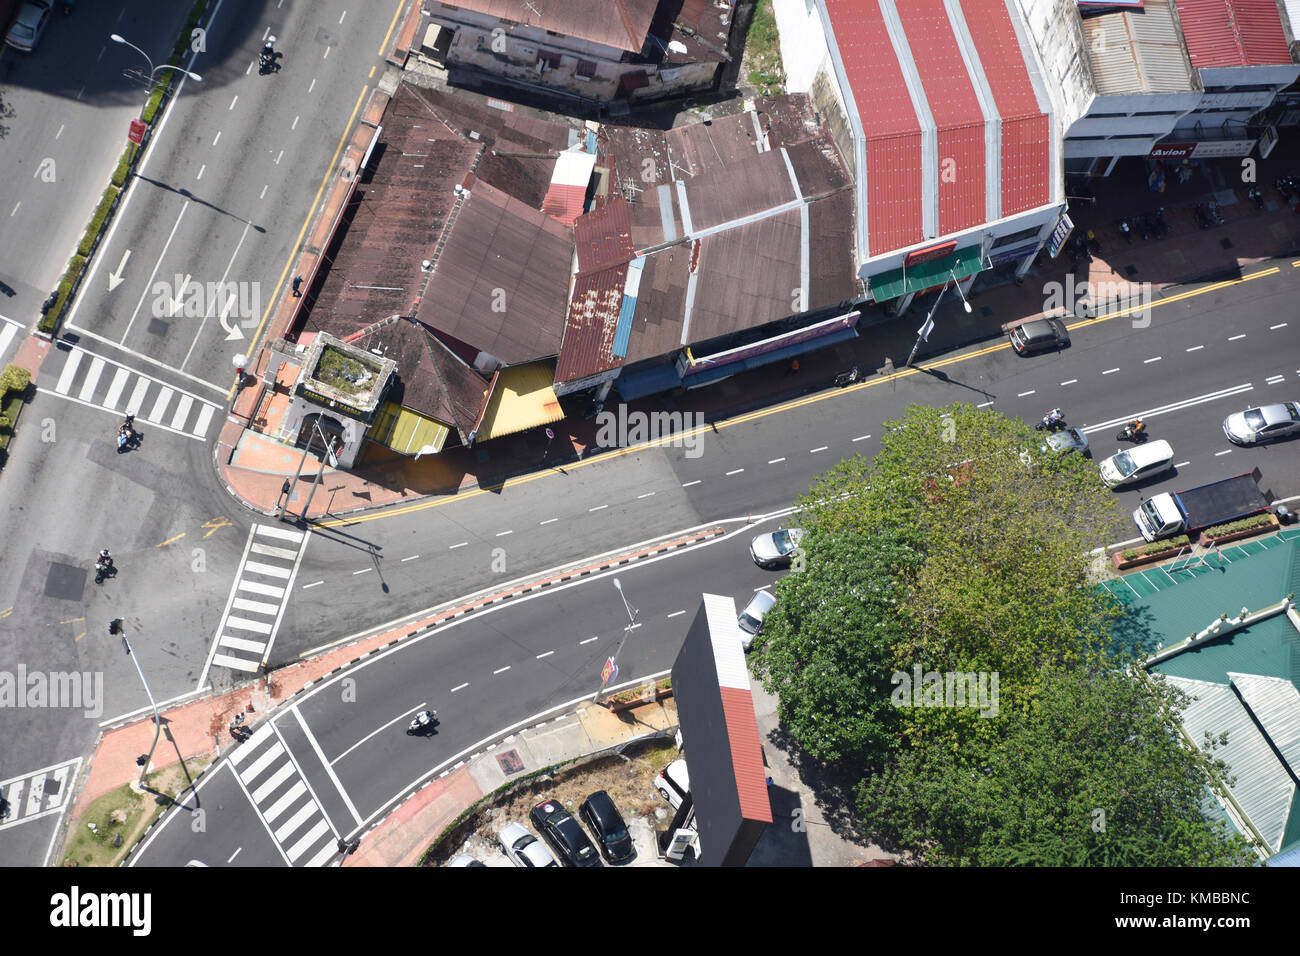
[208,524,308,671]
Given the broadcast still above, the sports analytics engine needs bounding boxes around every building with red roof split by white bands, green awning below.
[816,0,1063,306]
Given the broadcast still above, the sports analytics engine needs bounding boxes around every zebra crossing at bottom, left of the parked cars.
[230,722,338,866]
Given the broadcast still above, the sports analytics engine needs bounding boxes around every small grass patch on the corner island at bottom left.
[60,756,212,866]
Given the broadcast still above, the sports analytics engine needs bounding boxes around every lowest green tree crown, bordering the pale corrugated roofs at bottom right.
[858,667,1255,866]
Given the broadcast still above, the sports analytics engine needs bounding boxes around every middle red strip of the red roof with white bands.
[898,0,985,235]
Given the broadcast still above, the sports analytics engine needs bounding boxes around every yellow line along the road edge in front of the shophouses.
[317,251,1281,528]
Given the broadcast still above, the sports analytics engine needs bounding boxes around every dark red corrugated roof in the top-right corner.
[1178,0,1291,69]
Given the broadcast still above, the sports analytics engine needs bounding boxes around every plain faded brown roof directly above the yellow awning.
[417,179,573,365]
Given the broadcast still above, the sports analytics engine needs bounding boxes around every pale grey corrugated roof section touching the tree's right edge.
[1169,678,1296,853]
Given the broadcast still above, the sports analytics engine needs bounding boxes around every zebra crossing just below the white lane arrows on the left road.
[42,346,218,438]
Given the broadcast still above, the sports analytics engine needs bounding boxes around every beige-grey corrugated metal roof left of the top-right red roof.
[1083,0,1201,95]
